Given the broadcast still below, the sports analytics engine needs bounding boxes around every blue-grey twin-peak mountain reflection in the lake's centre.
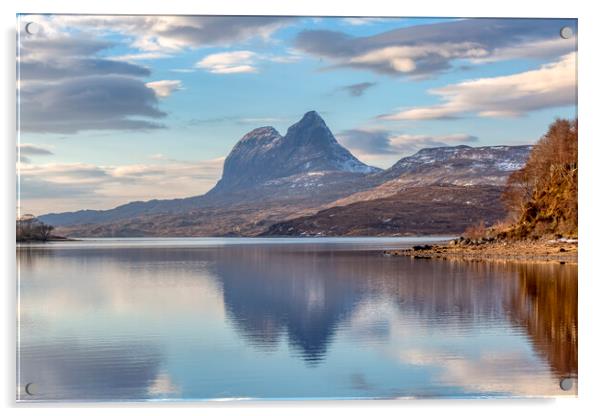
[215,247,366,363]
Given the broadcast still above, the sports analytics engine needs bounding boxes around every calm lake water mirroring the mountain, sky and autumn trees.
[17,238,577,401]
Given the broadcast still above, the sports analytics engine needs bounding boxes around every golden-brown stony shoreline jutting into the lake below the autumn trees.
[384,240,578,264]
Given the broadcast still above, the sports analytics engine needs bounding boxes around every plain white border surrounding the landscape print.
[0,0,602,416]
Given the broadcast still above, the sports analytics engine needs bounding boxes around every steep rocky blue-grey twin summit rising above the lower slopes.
[212,111,378,192]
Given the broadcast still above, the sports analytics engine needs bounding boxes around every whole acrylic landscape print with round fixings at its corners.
[16,14,578,402]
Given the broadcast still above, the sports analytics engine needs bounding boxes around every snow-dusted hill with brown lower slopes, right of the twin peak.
[262,145,532,236]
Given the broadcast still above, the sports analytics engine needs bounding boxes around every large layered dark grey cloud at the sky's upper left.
[18,26,172,134]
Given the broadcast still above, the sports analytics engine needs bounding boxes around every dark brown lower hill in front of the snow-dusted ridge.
[261,185,506,236]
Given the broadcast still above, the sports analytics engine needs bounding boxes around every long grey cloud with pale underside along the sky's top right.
[295,18,577,78]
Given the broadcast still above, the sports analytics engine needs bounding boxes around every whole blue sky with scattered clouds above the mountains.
[17,15,577,215]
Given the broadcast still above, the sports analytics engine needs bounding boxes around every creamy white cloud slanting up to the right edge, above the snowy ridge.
[379,52,577,120]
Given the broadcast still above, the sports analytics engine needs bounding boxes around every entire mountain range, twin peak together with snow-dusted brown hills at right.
[40,111,531,237]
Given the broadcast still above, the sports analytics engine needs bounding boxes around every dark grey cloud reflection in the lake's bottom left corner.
[19,340,162,400]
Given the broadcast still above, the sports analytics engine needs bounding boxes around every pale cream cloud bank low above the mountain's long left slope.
[18,157,224,215]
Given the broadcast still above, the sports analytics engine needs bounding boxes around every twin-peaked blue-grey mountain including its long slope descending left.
[40,111,381,231]
